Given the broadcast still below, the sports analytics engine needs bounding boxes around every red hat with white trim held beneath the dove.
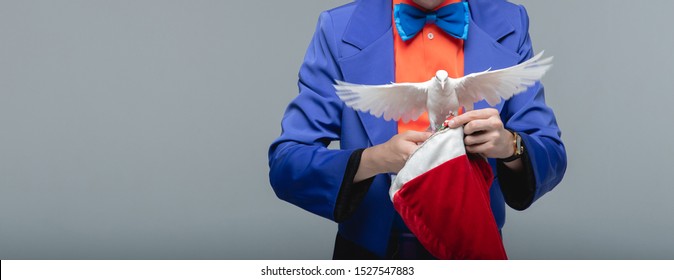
[390,128,507,259]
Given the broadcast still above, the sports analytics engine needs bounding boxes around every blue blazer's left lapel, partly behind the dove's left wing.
[338,0,398,145]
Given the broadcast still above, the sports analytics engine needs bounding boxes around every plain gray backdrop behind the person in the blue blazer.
[0,0,674,259]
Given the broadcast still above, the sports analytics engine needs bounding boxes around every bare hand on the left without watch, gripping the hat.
[353,131,432,183]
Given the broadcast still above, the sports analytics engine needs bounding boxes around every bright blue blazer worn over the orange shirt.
[269,0,566,256]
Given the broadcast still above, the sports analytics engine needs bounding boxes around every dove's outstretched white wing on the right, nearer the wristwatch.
[455,52,552,110]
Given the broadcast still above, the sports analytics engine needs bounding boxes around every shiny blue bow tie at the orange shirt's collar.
[393,2,470,41]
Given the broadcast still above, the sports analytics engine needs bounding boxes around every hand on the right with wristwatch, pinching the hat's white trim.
[449,108,515,158]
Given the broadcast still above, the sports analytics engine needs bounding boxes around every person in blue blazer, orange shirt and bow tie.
[269,0,566,259]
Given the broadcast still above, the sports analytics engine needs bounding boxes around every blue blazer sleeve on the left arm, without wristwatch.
[268,12,355,220]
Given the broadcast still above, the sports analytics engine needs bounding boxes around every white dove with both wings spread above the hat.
[335,52,552,131]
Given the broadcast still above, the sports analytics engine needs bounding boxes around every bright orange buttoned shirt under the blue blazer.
[391,0,463,133]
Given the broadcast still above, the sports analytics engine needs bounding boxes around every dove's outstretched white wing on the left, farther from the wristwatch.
[335,81,430,122]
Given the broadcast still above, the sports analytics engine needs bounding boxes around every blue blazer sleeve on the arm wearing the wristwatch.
[497,6,567,210]
